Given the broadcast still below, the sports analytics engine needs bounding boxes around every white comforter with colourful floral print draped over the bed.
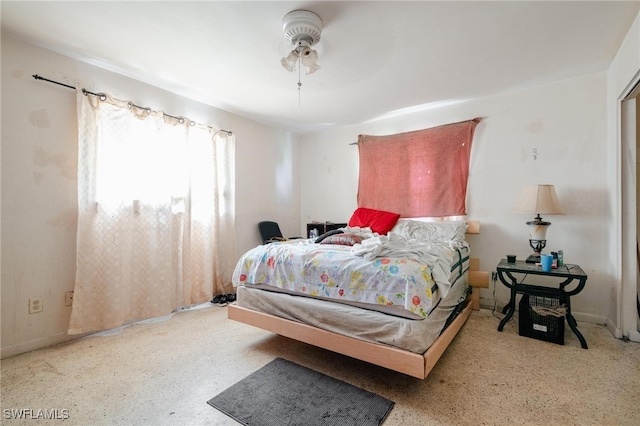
[233,234,469,318]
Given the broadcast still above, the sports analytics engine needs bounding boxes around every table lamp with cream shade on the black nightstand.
[514,185,564,263]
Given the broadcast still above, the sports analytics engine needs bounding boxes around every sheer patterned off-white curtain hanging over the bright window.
[69,91,236,334]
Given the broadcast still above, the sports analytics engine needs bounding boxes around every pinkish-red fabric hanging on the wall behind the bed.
[358,118,481,217]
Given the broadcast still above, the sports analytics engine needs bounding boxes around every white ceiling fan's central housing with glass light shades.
[280,10,322,75]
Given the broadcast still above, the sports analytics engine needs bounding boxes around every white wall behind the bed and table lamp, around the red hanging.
[300,73,612,323]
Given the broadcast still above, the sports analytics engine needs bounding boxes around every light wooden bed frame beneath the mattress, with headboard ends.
[228,222,489,379]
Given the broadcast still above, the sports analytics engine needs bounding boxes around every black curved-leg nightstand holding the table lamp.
[497,259,587,349]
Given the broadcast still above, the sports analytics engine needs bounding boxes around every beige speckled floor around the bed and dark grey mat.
[0,306,640,426]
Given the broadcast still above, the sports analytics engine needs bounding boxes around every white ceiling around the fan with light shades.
[1,1,640,132]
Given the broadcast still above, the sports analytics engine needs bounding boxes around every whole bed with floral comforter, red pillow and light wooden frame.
[228,217,489,379]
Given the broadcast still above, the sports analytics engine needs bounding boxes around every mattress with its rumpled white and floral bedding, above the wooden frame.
[233,220,469,354]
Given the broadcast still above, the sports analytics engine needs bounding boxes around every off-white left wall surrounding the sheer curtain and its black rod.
[1,34,300,357]
